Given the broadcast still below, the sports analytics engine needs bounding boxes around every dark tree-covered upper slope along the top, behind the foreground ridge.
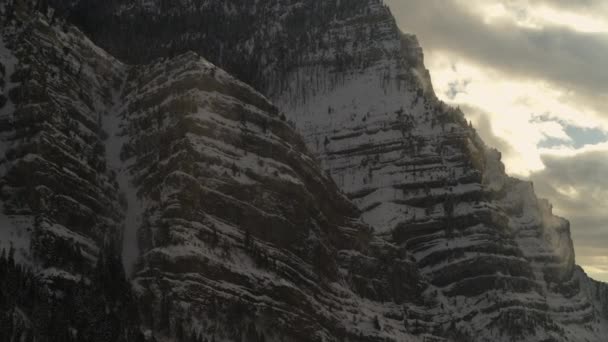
[49,0,409,99]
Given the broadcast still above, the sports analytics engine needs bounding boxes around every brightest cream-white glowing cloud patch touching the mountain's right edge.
[420,54,605,176]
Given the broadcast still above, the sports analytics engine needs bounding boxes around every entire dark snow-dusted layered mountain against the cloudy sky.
[0,0,608,341]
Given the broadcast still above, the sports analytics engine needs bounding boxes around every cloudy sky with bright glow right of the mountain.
[385,0,608,281]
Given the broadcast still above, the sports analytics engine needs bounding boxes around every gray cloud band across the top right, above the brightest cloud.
[389,0,608,113]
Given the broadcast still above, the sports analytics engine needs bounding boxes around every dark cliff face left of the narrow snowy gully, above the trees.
[1,0,122,276]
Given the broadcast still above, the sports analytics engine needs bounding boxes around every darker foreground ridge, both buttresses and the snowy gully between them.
[0,4,432,341]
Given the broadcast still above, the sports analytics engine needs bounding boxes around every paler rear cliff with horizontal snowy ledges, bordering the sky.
[268,5,606,341]
